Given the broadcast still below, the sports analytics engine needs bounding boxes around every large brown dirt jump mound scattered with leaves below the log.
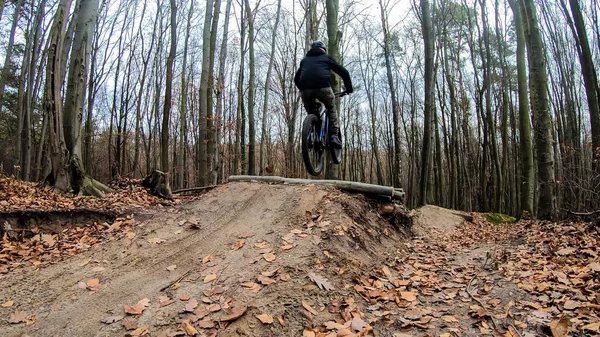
[0,183,454,337]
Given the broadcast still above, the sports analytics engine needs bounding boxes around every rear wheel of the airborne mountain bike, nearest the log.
[302,114,325,176]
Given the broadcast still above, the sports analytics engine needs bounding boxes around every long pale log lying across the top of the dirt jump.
[229,176,404,201]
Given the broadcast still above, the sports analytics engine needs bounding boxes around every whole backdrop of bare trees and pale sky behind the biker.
[0,0,600,218]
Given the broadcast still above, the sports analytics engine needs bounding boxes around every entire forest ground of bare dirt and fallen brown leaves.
[0,178,600,337]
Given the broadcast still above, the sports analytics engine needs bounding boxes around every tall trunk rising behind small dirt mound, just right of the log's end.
[420,0,435,205]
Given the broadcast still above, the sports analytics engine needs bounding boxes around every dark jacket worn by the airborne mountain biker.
[294,48,353,93]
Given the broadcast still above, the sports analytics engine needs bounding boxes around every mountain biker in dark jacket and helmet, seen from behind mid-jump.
[294,41,353,149]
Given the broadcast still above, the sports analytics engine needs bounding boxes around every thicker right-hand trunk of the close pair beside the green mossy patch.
[521,0,556,219]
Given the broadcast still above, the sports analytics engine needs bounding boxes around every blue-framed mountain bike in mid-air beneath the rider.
[302,91,348,176]
